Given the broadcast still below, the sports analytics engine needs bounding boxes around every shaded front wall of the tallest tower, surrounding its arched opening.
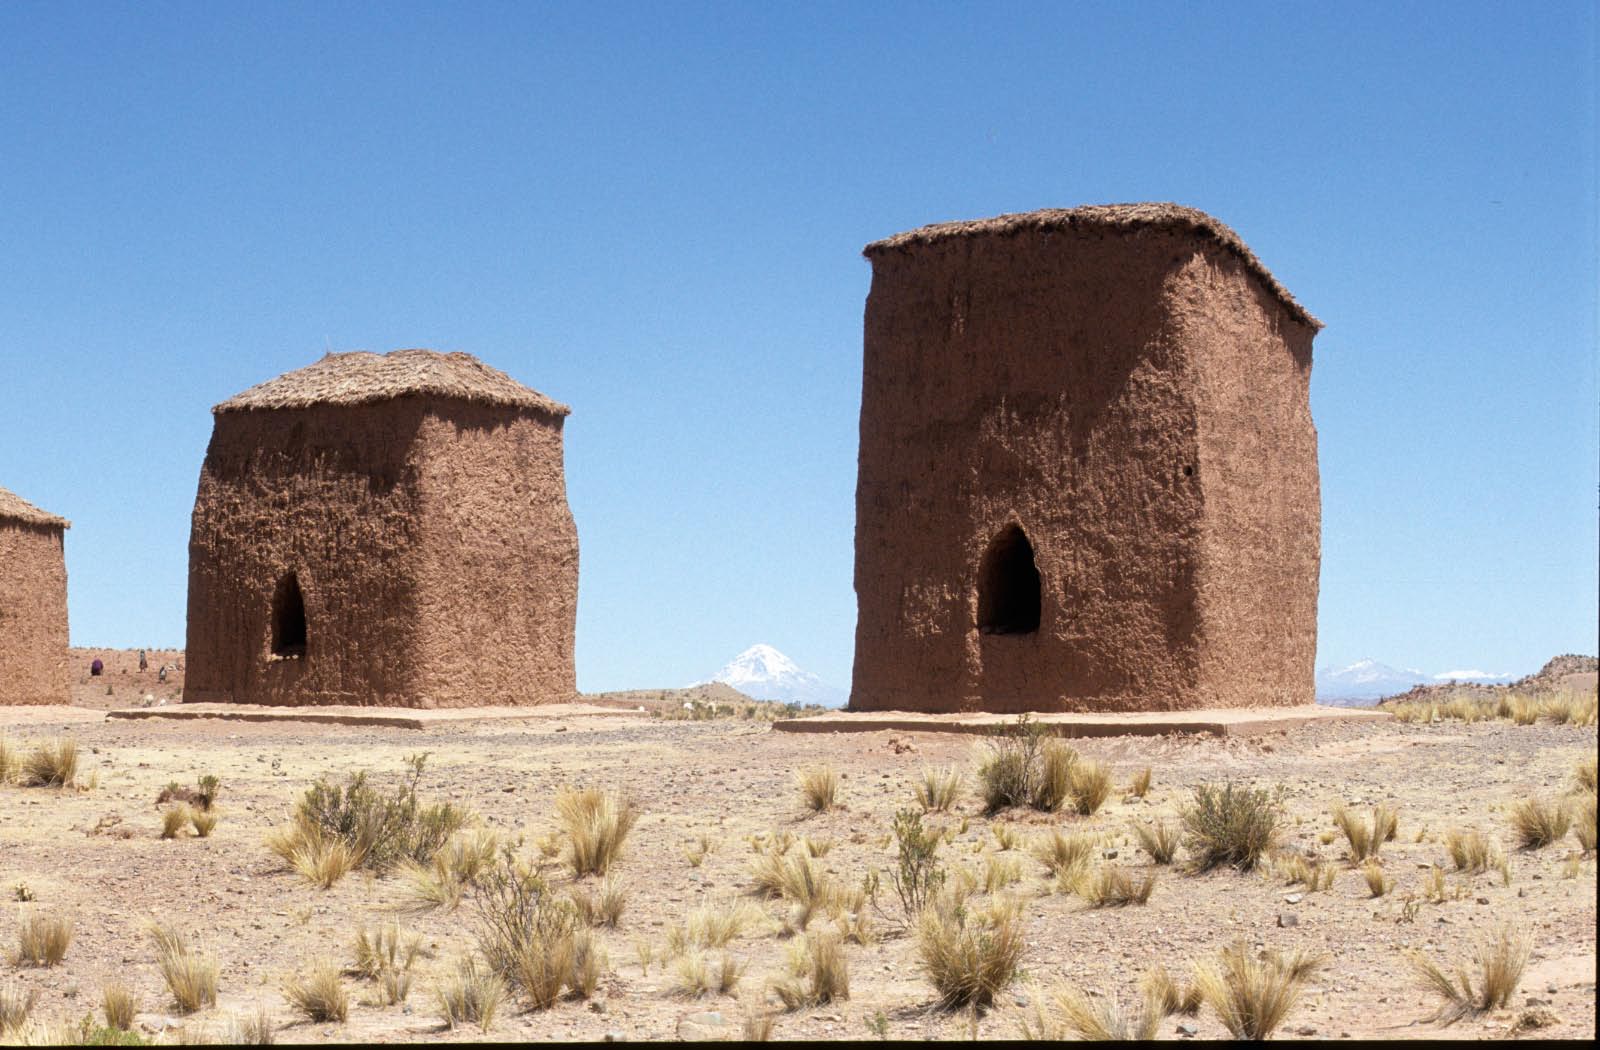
[851,227,1202,712]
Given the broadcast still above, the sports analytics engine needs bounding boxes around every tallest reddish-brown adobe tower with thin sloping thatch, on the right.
[850,203,1322,712]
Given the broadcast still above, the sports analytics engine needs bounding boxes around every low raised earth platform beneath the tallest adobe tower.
[773,704,1394,736]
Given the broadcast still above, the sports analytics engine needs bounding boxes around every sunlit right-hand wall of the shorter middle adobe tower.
[416,402,578,707]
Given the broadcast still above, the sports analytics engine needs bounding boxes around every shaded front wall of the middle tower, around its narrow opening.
[184,399,422,706]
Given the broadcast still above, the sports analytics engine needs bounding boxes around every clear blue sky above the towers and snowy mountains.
[0,2,1600,690]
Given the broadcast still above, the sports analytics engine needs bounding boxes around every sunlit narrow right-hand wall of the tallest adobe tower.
[1174,251,1322,707]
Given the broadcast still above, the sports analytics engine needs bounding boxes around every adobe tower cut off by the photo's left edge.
[0,488,72,706]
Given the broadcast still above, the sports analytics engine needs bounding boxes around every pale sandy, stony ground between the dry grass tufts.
[0,672,1595,1042]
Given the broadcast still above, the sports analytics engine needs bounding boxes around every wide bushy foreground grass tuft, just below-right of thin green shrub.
[917,903,1026,1010]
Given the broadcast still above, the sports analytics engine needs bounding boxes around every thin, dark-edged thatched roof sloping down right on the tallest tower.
[862,202,1322,328]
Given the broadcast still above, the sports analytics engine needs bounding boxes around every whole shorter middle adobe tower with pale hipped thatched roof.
[184,351,578,707]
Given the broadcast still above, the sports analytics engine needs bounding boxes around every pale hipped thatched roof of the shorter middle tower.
[211,351,571,416]
